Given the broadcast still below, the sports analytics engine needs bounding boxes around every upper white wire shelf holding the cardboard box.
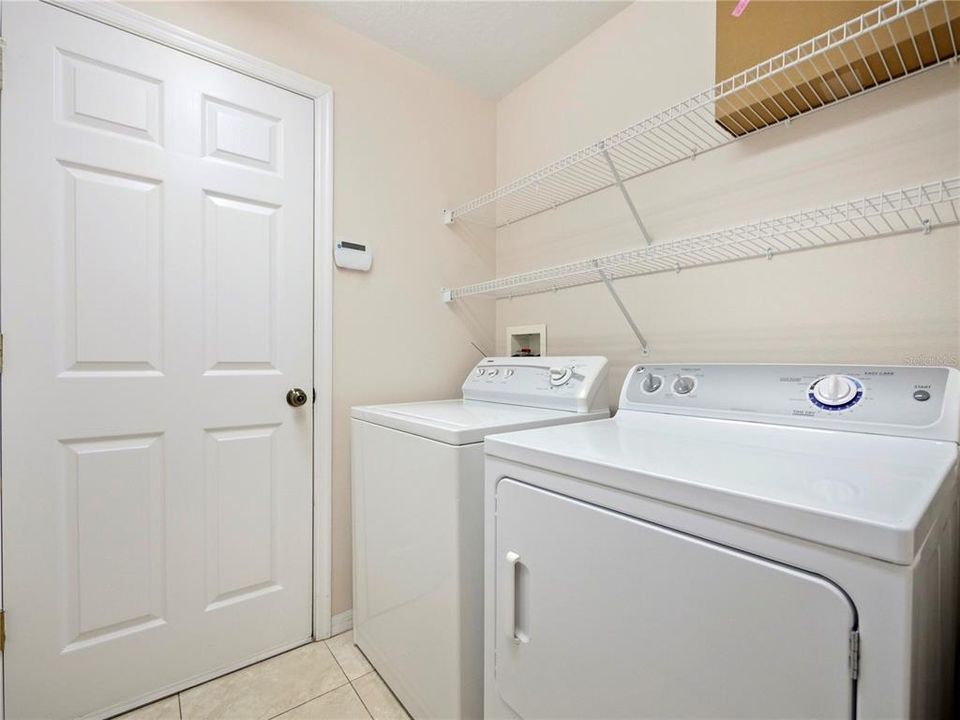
[444,0,960,227]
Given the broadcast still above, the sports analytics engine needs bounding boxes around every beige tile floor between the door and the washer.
[116,632,409,720]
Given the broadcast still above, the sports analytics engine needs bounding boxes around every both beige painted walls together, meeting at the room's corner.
[127,2,960,613]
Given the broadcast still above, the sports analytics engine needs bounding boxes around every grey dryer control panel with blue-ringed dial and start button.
[620,364,960,442]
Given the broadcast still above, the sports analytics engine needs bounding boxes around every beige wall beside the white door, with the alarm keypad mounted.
[131,2,495,613]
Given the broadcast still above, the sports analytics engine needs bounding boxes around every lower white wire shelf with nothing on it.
[443,177,960,302]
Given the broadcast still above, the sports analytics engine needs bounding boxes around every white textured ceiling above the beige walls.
[316,0,630,98]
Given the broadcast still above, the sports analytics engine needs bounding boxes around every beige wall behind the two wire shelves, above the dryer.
[497,2,960,410]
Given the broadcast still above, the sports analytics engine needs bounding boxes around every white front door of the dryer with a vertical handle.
[496,479,856,718]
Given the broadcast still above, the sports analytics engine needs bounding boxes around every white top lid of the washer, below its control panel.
[350,400,610,445]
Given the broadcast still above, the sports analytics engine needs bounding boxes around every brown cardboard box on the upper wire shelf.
[715,0,960,136]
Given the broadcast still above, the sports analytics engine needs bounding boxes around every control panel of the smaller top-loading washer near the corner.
[463,356,609,412]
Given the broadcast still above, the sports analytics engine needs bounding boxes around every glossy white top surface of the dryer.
[486,413,957,565]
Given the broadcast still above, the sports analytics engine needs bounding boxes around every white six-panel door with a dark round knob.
[0,2,314,719]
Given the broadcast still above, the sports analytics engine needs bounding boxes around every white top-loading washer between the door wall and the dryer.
[351,357,610,719]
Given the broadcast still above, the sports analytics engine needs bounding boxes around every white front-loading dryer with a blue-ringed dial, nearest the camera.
[484,365,960,719]
